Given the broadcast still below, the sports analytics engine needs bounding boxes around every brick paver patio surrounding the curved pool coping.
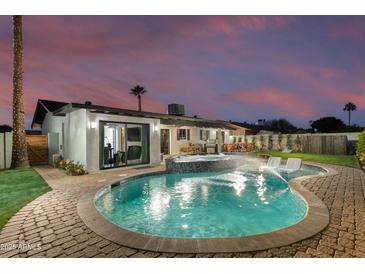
[0,166,365,257]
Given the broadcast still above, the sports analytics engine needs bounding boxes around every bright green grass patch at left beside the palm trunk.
[0,168,51,230]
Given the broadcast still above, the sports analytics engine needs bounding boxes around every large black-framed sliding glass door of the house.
[100,122,150,169]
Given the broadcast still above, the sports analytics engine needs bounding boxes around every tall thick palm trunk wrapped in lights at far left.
[11,15,29,168]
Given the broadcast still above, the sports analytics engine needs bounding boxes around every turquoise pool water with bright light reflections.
[95,166,323,238]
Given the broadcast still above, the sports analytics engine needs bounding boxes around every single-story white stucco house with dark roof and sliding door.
[32,100,246,171]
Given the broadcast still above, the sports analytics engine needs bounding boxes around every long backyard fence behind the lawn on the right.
[242,132,359,155]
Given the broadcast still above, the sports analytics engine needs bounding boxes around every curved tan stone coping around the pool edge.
[77,163,338,253]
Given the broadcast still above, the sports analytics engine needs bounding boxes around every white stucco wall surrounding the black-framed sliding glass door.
[86,112,161,171]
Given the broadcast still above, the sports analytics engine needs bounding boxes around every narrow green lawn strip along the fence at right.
[259,150,358,168]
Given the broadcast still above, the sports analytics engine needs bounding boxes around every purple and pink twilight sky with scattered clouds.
[0,16,365,128]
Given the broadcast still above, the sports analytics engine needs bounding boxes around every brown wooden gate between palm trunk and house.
[26,135,48,166]
